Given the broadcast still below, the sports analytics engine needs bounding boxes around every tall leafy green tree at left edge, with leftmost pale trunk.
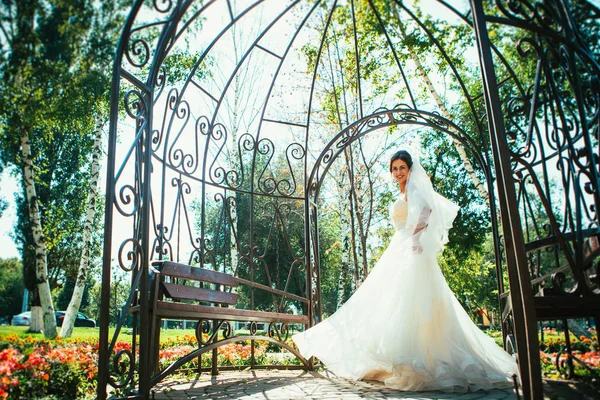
[0,0,119,337]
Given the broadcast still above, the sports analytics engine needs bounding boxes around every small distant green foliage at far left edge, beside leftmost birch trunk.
[0,258,25,316]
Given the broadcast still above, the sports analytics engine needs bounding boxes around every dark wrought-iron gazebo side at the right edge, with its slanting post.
[471,0,600,399]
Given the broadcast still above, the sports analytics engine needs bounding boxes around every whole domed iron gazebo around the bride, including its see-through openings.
[98,0,600,399]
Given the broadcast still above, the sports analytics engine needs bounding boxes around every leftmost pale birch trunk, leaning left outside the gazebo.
[21,130,57,339]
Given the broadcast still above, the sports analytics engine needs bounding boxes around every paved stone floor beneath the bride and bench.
[148,370,600,400]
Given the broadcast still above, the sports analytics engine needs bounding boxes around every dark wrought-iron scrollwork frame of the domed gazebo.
[98,0,600,399]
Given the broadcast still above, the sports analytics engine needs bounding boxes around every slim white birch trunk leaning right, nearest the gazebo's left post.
[60,113,104,338]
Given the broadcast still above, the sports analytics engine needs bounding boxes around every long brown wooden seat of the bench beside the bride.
[154,301,308,324]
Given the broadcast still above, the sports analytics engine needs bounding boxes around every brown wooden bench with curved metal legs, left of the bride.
[145,261,309,381]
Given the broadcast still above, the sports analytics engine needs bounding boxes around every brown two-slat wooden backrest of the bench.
[152,261,239,305]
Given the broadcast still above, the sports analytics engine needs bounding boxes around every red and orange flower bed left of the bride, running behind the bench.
[0,334,299,399]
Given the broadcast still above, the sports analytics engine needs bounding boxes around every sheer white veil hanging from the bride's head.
[406,153,460,256]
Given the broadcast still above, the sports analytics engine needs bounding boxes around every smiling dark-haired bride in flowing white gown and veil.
[293,150,517,391]
